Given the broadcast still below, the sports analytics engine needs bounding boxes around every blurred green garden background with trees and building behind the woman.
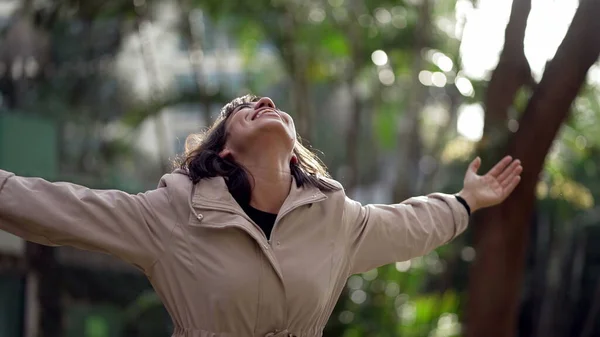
[0,0,600,337]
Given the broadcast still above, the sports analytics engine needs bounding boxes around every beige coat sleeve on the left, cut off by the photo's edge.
[0,170,176,274]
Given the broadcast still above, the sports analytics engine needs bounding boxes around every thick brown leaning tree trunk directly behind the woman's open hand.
[467,0,600,337]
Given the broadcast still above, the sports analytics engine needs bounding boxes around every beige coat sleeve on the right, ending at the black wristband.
[344,193,469,274]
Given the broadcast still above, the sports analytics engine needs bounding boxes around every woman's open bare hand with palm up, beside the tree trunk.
[458,156,523,212]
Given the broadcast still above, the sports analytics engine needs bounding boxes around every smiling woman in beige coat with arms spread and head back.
[0,96,522,337]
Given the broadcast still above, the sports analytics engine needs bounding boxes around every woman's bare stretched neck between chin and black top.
[236,151,292,214]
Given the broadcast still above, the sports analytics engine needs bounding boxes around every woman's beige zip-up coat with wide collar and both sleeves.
[0,170,468,337]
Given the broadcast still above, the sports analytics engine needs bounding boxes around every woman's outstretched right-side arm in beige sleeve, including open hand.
[344,157,523,274]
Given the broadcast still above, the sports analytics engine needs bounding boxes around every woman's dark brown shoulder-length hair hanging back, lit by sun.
[176,95,338,203]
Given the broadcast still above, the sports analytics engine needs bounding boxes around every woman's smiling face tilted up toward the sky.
[221,97,296,154]
